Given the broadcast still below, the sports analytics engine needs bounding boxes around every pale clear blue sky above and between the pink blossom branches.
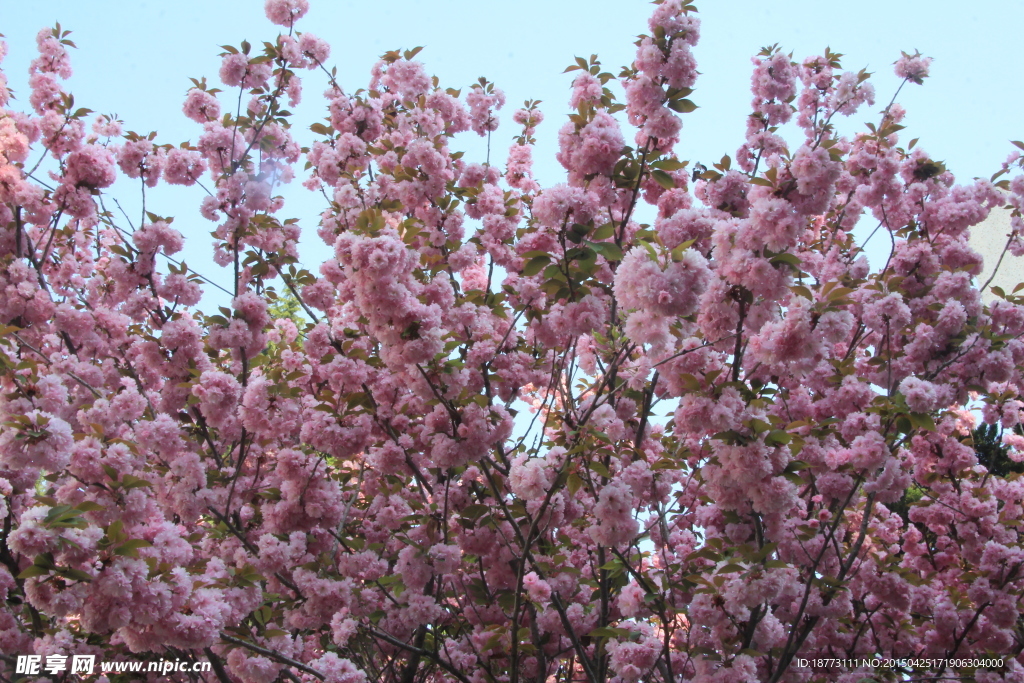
[0,0,1024,296]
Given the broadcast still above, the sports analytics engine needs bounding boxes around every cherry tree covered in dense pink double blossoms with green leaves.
[0,0,1024,683]
